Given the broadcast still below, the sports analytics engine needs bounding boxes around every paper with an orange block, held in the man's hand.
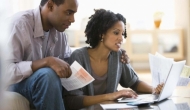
[60,61,94,91]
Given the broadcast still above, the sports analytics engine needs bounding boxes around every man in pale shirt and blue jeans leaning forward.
[7,0,128,110]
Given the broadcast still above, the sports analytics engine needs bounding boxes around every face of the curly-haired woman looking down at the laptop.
[102,21,125,51]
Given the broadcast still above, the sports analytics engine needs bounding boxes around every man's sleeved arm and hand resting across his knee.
[5,19,71,84]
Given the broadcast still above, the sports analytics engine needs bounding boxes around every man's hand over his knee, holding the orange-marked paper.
[48,57,72,78]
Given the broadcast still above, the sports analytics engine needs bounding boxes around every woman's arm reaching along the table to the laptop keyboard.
[64,89,137,110]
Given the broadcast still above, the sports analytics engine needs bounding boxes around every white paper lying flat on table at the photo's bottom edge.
[100,103,137,110]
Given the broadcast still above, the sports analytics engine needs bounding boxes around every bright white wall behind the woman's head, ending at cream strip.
[69,0,175,30]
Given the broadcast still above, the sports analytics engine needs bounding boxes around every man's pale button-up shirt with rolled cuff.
[7,7,72,84]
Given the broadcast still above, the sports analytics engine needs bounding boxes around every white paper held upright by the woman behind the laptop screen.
[149,52,174,87]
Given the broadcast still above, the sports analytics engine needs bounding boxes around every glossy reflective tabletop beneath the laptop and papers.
[81,86,190,110]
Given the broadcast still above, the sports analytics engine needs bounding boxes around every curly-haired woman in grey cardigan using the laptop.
[65,9,162,109]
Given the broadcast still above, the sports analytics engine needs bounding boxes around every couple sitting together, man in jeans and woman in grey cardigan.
[7,0,162,110]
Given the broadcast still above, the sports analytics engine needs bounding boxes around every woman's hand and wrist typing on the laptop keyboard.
[107,89,137,101]
